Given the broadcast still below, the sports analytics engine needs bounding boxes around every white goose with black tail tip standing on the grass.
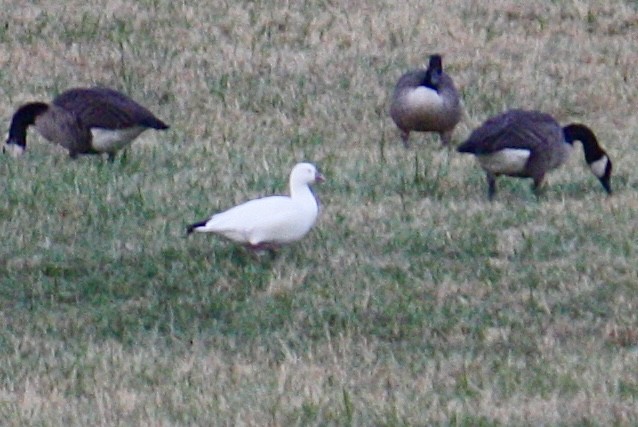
[187,163,324,250]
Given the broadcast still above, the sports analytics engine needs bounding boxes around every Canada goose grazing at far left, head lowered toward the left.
[3,87,168,160]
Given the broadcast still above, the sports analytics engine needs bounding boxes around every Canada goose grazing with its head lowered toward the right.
[458,110,612,199]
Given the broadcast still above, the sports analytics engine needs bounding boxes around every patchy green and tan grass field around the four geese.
[0,0,638,426]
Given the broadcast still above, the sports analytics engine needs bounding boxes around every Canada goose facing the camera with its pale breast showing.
[390,55,461,148]
